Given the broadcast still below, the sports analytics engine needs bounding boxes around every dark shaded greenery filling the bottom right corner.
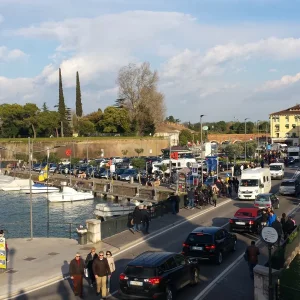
[280,255,300,300]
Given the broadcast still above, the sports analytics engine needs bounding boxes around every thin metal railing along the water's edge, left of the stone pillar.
[0,221,79,239]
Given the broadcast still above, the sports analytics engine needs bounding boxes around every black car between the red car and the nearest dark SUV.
[182,227,237,265]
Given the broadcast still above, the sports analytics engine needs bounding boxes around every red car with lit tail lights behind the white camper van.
[229,207,262,232]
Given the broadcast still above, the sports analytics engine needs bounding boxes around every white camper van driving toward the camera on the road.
[238,168,272,200]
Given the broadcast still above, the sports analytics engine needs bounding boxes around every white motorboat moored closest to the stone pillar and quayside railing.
[94,199,152,219]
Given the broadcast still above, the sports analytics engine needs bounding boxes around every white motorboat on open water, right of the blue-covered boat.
[48,186,94,202]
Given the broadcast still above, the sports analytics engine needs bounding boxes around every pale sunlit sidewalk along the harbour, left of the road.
[0,198,231,300]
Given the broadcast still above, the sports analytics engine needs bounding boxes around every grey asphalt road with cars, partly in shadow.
[10,164,299,300]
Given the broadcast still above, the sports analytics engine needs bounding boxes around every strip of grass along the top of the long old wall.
[0,136,164,143]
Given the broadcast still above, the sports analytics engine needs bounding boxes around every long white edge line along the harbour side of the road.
[6,199,232,300]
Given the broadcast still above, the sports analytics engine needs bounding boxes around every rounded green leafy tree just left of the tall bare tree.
[98,106,130,133]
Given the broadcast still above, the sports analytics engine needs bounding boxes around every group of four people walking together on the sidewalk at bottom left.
[69,247,116,299]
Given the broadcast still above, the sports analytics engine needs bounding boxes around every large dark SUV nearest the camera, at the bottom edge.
[119,251,200,300]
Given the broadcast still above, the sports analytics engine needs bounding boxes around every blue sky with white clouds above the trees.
[0,0,300,123]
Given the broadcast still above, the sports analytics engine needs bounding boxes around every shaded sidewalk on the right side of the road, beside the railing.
[203,206,300,300]
